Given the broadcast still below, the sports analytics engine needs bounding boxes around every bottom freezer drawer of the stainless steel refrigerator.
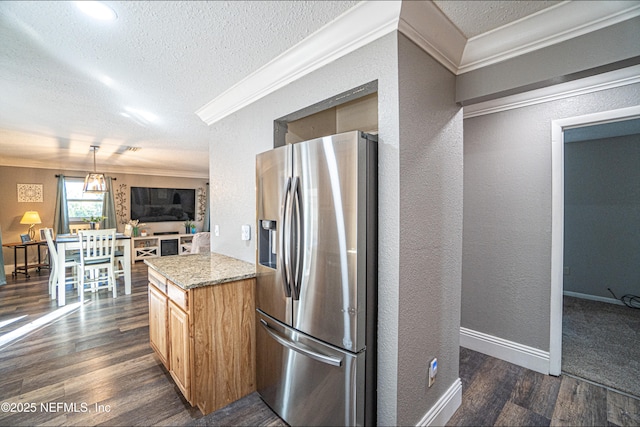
[256,311,365,426]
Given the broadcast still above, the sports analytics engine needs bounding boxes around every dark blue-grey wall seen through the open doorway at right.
[563,134,640,298]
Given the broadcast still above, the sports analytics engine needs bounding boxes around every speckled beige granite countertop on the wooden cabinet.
[144,253,256,289]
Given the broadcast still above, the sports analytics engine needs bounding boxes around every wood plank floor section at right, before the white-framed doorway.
[447,348,640,426]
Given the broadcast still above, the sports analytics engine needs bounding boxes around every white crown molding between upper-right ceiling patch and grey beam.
[458,0,640,74]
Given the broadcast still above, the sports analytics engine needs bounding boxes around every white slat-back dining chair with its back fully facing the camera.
[78,228,118,303]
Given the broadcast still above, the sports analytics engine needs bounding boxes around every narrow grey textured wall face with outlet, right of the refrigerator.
[398,36,462,425]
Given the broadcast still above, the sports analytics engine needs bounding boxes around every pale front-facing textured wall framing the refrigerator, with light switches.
[210,34,402,425]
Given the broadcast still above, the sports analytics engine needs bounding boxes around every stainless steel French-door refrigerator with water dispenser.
[256,131,378,425]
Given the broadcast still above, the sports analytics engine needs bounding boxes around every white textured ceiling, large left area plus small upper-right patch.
[0,0,600,177]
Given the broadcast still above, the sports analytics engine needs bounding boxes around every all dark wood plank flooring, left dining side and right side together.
[0,263,640,426]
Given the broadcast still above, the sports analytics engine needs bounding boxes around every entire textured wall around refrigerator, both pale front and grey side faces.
[210,30,462,425]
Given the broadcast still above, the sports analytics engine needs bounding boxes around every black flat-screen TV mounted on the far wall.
[131,187,196,223]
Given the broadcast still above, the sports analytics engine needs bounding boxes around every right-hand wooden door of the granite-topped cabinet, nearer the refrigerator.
[169,300,191,402]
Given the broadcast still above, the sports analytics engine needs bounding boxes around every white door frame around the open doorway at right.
[549,106,640,376]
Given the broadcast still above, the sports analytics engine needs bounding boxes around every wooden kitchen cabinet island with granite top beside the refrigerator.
[144,253,256,415]
